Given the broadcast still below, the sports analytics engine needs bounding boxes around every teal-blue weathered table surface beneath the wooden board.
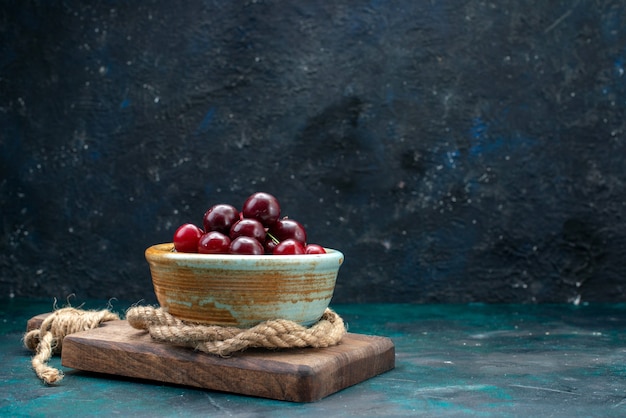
[0,299,626,417]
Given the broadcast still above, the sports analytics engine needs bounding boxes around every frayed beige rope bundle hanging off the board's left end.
[24,308,120,385]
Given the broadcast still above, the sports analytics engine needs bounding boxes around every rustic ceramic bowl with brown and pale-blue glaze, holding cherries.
[145,243,344,328]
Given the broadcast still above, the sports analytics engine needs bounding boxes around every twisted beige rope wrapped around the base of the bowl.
[126,306,346,357]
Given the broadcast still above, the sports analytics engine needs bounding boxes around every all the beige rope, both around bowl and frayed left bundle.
[24,306,347,385]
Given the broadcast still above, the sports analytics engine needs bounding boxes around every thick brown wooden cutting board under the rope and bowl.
[28,314,395,402]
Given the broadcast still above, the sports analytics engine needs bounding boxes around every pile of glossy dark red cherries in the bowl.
[174,192,326,255]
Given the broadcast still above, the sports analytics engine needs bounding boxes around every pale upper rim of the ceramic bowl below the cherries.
[145,242,345,262]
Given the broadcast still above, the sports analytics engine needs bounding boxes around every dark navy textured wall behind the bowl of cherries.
[0,0,626,302]
